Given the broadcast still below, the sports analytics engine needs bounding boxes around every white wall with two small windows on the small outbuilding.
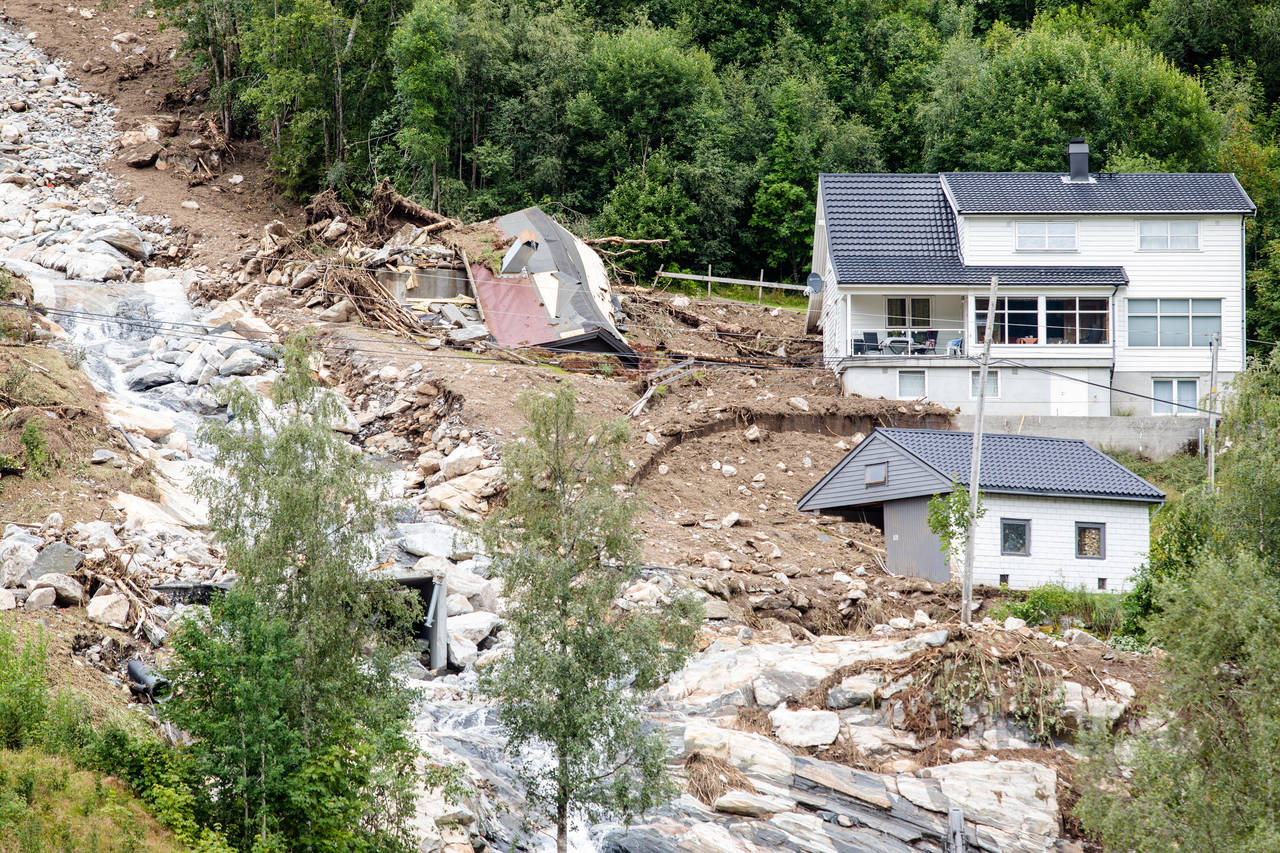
[973,494,1151,592]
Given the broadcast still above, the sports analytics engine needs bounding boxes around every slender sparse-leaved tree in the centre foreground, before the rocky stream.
[481,386,700,852]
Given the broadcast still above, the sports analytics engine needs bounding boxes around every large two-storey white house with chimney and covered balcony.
[808,140,1256,416]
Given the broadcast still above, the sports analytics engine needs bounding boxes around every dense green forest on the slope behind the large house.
[160,0,1280,330]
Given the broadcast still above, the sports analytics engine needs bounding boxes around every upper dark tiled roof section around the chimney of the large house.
[942,172,1257,214]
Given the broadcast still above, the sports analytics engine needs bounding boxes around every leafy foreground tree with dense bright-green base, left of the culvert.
[185,330,415,850]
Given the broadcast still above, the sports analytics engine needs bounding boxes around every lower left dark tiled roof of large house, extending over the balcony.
[818,174,1129,287]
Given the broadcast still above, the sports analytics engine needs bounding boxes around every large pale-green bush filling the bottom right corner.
[1076,552,1280,853]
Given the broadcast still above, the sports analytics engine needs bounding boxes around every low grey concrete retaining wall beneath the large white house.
[955,410,1208,460]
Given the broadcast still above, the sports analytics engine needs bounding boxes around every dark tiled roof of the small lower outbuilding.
[874,427,1165,502]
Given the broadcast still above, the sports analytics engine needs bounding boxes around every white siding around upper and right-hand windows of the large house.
[960,215,1244,375]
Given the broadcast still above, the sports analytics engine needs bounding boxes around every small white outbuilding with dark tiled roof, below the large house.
[799,428,1165,592]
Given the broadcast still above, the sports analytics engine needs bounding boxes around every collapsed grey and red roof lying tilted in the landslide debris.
[471,207,639,361]
